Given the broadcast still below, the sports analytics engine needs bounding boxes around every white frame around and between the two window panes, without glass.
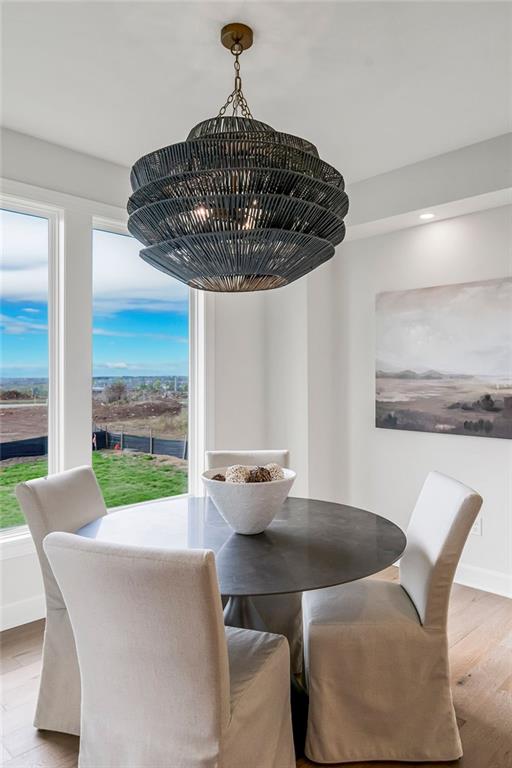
[0,179,210,544]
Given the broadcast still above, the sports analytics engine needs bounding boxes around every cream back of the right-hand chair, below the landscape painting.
[400,472,482,629]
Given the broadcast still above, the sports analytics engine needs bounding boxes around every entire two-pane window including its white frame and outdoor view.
[0,198,203,541]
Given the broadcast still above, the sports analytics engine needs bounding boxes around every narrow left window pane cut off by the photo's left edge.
[0,209,49,529]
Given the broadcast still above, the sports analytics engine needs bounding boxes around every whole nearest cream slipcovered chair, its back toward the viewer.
[44,533,295,768]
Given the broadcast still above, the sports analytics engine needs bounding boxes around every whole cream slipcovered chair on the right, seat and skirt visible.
[303,472,482,764]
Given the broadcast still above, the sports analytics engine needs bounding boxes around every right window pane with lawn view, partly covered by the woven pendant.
[92,229,189,507]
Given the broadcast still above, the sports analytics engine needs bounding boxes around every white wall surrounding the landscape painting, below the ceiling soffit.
[334,206,512,596]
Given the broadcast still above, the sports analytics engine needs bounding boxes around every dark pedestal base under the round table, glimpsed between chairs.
[224,595,309,759]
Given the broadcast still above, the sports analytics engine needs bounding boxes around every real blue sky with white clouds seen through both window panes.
[0,211,188,378]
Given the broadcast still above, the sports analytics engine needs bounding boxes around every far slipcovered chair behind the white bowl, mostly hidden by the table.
[206,450,302,673]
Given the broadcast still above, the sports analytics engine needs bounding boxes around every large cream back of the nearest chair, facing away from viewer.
[44,533,230,766]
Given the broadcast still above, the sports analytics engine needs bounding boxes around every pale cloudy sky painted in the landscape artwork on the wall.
[376,278,512,379]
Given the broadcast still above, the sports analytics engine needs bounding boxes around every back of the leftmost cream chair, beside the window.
[16,467,107,609]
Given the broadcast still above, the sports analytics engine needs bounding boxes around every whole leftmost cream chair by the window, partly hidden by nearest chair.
[16,467,107,735]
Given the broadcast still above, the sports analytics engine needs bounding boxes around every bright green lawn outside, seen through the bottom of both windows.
[0,451,188,528]
